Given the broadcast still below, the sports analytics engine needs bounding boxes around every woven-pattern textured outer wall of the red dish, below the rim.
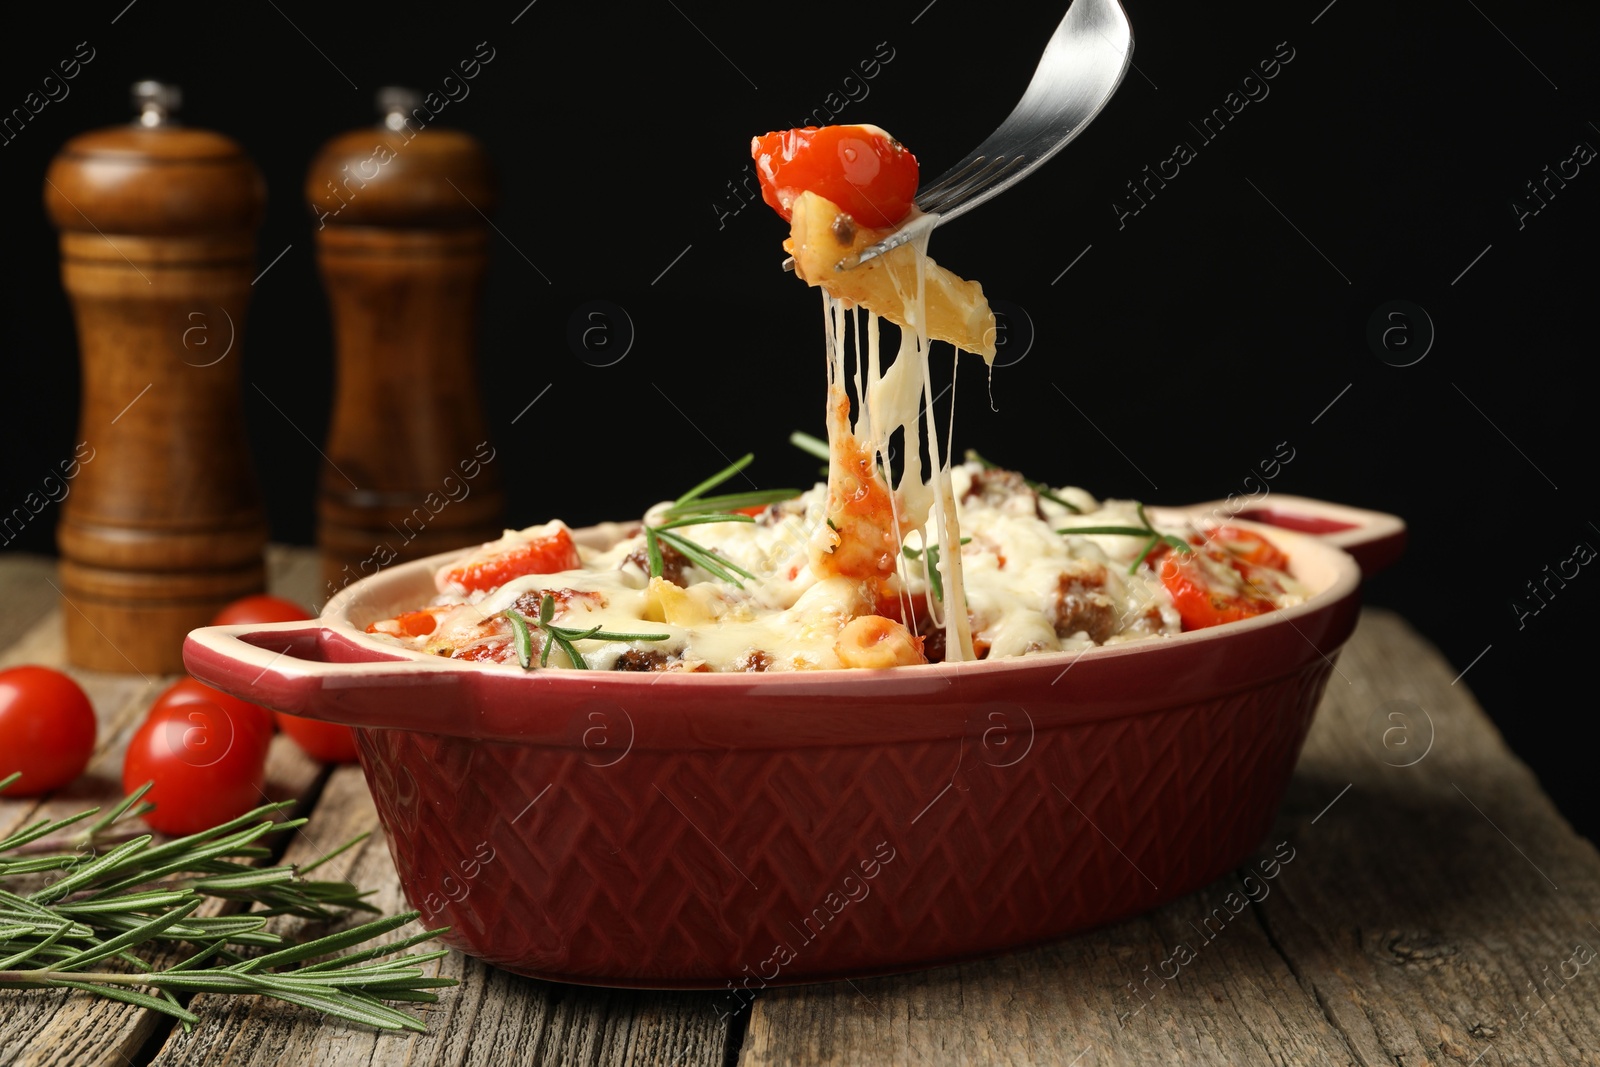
[360,659,1330,989]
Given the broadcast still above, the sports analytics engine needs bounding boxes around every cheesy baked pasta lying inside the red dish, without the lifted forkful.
[370,459,1304,672]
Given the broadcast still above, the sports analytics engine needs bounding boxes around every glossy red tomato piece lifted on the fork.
[750,126,917,229]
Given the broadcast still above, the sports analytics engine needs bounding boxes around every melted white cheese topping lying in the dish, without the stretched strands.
[356,463,1306,670]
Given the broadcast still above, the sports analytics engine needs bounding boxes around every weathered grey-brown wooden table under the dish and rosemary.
[0,549,1600,1067]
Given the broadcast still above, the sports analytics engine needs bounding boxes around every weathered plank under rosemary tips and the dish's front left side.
[152,766,726,1067]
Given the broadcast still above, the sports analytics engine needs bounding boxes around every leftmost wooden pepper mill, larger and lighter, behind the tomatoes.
[45,82,267,673]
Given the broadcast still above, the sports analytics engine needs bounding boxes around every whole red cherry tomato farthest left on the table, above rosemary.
[0,667,94,797]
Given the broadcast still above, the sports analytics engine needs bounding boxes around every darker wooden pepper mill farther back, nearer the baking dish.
[306,88,504,595]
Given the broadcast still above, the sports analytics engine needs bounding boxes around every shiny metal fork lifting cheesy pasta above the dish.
[784,0,1133,270]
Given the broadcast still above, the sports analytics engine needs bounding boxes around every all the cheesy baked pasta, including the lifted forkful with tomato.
[370,126,1304,672]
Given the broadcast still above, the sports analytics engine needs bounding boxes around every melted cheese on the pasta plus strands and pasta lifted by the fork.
[373,167,1304,672]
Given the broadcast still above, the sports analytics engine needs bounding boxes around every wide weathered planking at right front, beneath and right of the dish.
[741,611,1600,1067]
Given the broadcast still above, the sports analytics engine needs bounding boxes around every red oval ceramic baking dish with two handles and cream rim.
[184,496,1405,989]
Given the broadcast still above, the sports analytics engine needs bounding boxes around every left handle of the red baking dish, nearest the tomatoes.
[184,619,482,726]
